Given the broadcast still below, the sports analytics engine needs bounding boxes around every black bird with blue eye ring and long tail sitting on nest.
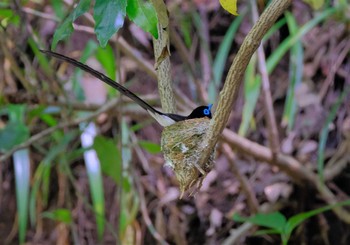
[40,49,213,127]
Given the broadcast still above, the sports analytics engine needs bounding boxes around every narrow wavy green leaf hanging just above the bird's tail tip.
[51,0,90,49]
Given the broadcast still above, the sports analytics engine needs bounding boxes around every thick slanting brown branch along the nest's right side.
[199,0,292,178]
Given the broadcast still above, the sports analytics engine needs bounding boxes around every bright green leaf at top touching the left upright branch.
[126,0,158,39]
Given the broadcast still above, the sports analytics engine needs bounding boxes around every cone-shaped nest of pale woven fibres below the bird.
[161,118,215,196]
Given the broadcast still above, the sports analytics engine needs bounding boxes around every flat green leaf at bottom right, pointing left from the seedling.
[233,212,287,233]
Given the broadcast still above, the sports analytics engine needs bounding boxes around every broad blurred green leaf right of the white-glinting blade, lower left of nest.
[93,136,122,185]
